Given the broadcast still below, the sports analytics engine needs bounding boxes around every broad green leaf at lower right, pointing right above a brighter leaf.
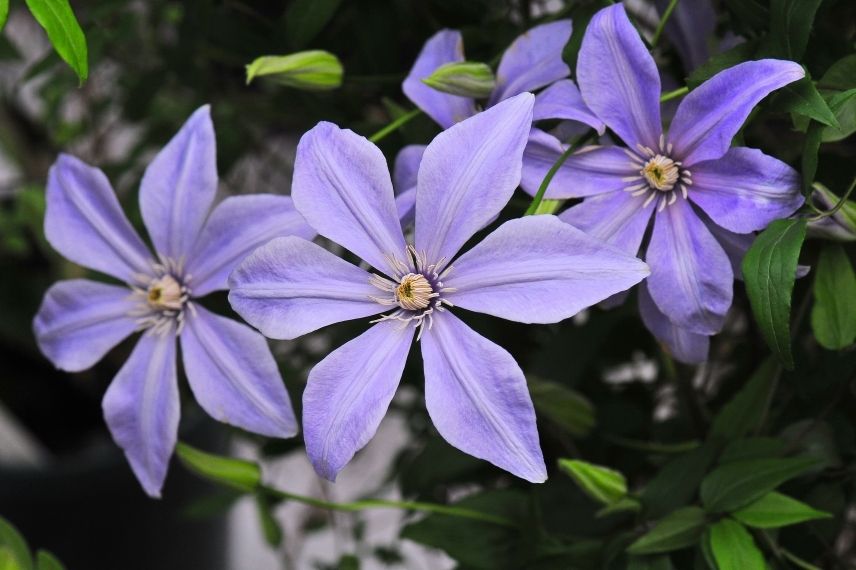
[701,457,817,513]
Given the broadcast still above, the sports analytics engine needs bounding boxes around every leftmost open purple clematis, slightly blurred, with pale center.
[33,106,314,497]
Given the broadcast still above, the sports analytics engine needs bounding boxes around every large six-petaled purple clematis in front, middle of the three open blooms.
[229,93,648,482]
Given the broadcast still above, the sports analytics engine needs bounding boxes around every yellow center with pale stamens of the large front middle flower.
[369,245,454,340]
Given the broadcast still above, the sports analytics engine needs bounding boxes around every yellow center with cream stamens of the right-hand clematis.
[622,135,693,212]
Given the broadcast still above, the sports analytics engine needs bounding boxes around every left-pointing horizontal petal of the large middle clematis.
[229,237,386,339]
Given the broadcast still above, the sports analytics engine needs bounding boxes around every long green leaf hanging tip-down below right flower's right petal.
[743,218,806,370]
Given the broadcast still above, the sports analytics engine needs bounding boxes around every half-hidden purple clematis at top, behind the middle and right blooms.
[404,20,606,205]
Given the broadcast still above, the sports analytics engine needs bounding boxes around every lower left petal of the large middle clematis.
[303,321,415,481]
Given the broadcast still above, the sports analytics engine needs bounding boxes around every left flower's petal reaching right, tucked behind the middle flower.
[187,194,315,297]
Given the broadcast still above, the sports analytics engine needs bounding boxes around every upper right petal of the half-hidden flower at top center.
[488,20,571,105]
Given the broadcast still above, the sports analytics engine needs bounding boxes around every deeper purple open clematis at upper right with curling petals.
[547,5,804,362]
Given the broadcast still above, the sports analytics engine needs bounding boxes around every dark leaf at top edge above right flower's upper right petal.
[767,0,823,61]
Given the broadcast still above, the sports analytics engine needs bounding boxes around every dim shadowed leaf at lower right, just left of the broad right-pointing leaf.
[640,442,717,518]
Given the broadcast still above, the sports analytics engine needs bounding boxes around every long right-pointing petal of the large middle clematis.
[445,216,649,323]
